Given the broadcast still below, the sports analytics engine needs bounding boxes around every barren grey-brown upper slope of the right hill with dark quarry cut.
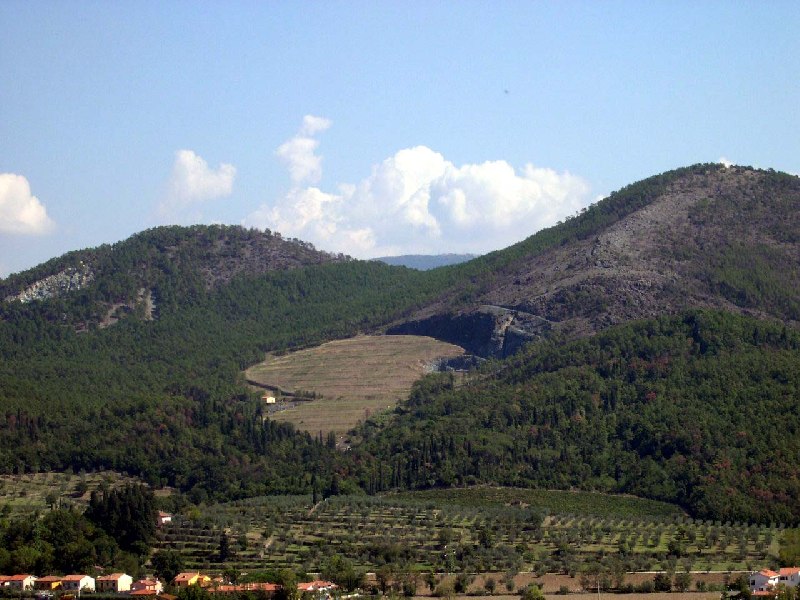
[390,165,800,356]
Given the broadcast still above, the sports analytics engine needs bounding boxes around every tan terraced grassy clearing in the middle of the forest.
[245,335,464,434]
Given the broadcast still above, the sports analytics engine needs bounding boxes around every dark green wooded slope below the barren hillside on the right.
[360,310,800,524]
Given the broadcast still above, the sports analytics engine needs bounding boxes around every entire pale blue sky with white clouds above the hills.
[0,0,800,276]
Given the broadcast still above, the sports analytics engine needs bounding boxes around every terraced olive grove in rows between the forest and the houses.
[153,492,781,575]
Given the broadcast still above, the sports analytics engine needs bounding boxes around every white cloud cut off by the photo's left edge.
[0,173,55,235]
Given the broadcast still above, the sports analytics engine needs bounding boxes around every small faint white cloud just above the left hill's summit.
[158,150,236,218]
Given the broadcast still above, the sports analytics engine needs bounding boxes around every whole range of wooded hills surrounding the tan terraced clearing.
[0,165,800,522]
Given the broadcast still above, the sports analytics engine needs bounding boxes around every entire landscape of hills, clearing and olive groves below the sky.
[0,165,800,595]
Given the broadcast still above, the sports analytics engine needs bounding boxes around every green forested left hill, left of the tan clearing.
[0,227,444,500]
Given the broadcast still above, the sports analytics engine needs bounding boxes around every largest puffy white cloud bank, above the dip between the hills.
[244,117,591,258]
